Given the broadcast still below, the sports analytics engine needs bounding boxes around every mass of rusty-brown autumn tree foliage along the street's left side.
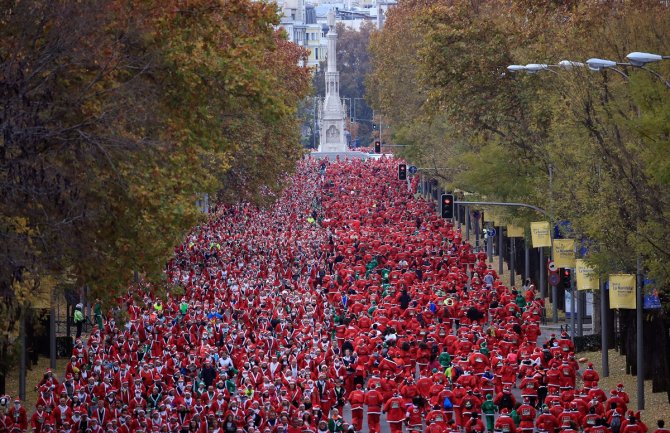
[0,0,310,391]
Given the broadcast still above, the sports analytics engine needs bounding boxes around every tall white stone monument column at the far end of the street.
[319,10,347,152]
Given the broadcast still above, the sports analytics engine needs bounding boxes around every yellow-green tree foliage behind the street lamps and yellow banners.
[368,0,670,398]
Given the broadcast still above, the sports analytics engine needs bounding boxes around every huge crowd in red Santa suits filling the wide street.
[0,159,668,433]
